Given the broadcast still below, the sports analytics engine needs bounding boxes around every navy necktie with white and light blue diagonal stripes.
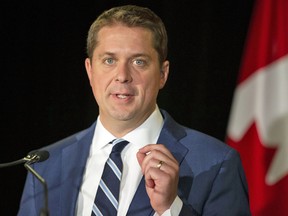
[91,139,129,216]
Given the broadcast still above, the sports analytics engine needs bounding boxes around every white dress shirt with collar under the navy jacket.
[76,107,182,216]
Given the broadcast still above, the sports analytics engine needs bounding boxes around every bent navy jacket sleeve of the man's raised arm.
[179,149,251,216]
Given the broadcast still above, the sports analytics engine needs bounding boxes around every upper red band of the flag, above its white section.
[239,0,288,83]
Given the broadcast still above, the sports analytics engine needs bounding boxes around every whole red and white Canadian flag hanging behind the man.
[227,0,288,216]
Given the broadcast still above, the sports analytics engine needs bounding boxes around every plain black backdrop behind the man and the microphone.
[0,0,253,215]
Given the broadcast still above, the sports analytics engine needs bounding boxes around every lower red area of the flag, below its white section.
[227,124,288,216]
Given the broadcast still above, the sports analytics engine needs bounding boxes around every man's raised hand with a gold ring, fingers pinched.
[137,144,179,215]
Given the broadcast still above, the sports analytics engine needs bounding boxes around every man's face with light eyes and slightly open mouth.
[85,25,169,130]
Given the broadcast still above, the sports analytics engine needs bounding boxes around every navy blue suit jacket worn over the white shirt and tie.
[18,110,250,216]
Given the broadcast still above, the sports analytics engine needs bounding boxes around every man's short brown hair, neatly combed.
[87,5,168,63]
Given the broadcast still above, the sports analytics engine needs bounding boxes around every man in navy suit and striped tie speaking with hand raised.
[19,5,250,216]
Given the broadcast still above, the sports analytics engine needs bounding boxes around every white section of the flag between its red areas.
[228,55,288,185]
